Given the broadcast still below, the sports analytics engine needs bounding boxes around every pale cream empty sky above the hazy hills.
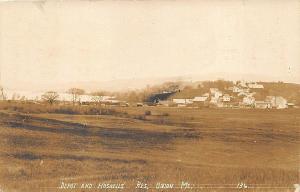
[0,0,300,89]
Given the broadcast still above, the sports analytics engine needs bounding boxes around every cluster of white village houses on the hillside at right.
[159,81,294,109]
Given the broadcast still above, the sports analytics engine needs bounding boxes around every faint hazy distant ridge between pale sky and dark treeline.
[3,74,300,93]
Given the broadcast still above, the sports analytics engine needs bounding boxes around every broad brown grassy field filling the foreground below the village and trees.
[0,104,300,192]
